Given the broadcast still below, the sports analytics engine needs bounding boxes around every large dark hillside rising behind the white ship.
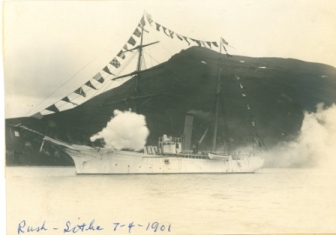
[6,47,336,165]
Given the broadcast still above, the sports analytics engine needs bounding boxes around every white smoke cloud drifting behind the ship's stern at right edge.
[267,104,336,169]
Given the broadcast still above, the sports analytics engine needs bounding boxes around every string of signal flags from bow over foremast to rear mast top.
[31,12,231,118]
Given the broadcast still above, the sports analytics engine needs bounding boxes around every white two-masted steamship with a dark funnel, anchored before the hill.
[9,12,264,175]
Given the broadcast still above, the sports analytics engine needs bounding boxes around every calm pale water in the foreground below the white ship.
[6,167,336,235]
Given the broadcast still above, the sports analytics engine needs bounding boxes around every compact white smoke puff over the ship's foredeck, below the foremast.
[90,110,149,151]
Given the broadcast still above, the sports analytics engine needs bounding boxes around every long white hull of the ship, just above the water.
[65,149,264,175]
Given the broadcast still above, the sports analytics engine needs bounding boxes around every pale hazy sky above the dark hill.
[3,0,336,118]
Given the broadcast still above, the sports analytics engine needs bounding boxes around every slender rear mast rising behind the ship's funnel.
[212,40,222,153]
